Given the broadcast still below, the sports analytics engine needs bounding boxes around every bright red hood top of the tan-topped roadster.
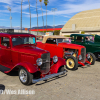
[58,42,85,49]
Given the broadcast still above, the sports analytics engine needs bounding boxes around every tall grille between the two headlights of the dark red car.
[40,53,50,74]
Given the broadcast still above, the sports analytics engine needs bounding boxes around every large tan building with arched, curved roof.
[60,9,100,35]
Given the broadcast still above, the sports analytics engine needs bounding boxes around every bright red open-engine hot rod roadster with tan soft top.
[37,36,95,70]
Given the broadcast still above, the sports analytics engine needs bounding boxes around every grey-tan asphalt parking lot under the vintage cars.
[0,61,100,100]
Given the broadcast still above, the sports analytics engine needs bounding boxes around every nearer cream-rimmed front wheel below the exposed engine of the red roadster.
[66,56,78,70]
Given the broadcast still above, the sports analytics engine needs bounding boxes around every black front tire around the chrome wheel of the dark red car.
[18,67,33,85]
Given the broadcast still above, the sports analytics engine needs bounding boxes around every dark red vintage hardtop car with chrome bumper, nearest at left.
[0,33,66,85]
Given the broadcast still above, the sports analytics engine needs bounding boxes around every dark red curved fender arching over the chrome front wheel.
[5,62,39,73]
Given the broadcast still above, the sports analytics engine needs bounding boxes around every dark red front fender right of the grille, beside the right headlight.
[50,57,66,74]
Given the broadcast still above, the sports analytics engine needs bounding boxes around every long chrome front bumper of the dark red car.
[32,71,67,83]
